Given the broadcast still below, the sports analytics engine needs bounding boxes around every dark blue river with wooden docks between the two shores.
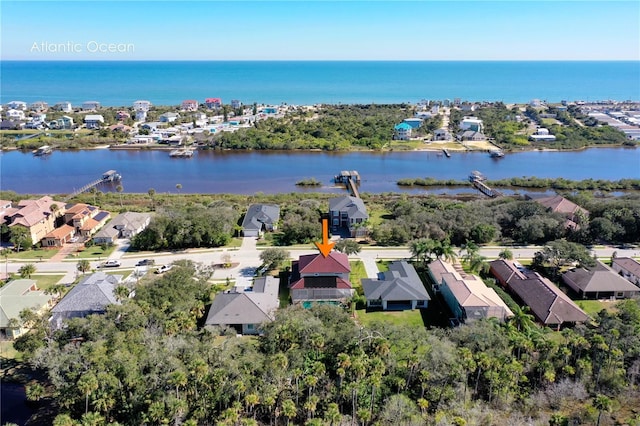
[0,148,640,194]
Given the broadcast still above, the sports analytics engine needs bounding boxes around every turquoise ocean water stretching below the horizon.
[0,61,640,106]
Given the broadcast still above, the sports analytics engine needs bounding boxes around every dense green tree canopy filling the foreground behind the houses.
[17,274,640,425]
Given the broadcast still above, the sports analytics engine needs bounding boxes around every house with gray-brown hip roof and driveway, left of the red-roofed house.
[205,276,280,334]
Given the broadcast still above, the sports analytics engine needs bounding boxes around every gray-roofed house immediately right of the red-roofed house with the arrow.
[361,260,431,311]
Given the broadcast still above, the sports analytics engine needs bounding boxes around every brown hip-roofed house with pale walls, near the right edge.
[562,260,640,299]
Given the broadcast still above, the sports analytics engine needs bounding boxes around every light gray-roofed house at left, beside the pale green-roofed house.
[50,272,122,329]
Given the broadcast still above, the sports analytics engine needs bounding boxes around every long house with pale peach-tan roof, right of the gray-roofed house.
[429,259,513,322]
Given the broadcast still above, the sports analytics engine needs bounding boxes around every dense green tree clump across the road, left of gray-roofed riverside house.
[131,205,238,250]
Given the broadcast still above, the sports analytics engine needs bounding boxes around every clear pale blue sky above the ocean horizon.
[0,0,640,60]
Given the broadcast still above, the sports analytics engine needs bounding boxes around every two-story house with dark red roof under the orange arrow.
[289,251,354,308]
